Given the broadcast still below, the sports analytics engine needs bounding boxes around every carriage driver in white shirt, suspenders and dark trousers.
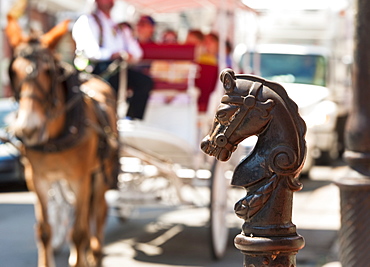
[72,0,153,119]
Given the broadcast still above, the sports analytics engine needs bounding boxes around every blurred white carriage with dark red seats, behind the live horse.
[112,44,243,259]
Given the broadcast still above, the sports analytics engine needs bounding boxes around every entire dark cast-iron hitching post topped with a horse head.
[201,69,306,267]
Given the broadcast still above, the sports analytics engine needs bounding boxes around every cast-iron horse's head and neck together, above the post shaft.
[201,69,306,180]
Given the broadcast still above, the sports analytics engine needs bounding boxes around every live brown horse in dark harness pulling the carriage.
[6,17,118,266]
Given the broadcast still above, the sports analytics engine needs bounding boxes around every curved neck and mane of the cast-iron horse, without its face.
[225,73,306,186]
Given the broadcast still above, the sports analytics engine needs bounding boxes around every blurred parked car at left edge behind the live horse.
[0,98,25,184]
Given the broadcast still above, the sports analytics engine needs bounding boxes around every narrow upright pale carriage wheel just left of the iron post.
[210,160,229,259]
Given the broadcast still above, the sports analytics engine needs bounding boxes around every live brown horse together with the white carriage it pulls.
[7,13,247,266]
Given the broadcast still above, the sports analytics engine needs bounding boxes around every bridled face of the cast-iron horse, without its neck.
[201,69,274,161]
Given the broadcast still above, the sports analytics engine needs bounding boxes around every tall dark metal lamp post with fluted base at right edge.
[337,0,370,267]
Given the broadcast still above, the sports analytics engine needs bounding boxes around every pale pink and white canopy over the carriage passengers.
[120,0,258,114]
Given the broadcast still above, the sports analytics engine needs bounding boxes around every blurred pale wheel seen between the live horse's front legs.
[48,182,73,252]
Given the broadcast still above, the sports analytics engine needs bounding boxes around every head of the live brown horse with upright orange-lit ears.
[6,16,68,146]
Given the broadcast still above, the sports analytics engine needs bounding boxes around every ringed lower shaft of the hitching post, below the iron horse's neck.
[234,178,305,267]
